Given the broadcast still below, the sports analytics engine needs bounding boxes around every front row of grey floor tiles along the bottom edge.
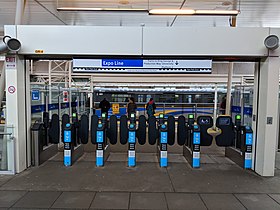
[1,191,280,210]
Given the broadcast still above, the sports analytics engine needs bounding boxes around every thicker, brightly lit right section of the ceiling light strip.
[149,9,239,16]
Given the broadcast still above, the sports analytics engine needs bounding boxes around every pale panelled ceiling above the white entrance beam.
[0,0,280,35]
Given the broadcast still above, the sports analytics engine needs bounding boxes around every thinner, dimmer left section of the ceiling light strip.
[57,7,148,12]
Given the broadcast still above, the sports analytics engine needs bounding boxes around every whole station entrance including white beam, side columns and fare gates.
[1,26,279,176]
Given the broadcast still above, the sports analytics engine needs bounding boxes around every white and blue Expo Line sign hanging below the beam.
[73,59,212,73]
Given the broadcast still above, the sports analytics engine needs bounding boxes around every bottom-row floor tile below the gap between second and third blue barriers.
[90,192,129,209]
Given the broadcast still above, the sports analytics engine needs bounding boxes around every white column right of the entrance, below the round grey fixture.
[253,57,280,176]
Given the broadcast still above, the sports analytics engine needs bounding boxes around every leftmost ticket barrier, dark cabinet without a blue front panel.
[31,112,60,166]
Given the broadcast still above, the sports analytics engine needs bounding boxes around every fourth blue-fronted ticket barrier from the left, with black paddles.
[148,114,175,167]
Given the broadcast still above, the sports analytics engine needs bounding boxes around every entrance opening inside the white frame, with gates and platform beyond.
[27,59,255,174]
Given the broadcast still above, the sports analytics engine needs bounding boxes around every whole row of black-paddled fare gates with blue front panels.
[34,113,253,169]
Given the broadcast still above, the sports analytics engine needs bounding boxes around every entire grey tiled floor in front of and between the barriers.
[0,153,280,210]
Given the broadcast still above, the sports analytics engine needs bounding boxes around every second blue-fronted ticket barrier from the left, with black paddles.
[91,113,117,167]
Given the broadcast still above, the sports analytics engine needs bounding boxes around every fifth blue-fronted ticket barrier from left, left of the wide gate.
[177,114,201,168]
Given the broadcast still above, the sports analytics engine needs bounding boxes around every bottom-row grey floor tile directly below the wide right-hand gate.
[200,194,245,210]
